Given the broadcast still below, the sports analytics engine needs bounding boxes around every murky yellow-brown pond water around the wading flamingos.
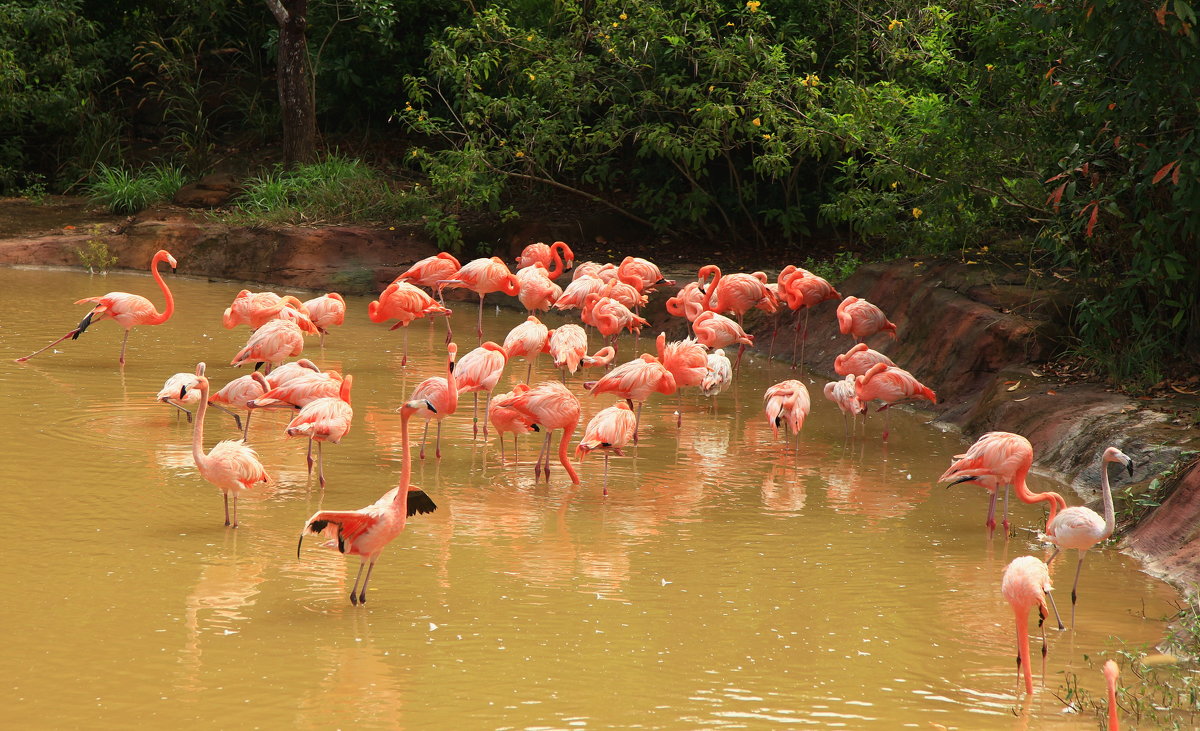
[0,270,1175,729]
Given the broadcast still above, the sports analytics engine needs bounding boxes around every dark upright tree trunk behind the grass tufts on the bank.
[266,0,317,167]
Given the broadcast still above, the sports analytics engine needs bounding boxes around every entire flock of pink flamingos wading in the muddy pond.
[18,241,1133,729]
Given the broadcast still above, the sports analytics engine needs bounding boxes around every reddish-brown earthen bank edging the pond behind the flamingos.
[0,209,1200,589]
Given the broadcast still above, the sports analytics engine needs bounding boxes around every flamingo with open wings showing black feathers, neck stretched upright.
[296,401,438,606]
